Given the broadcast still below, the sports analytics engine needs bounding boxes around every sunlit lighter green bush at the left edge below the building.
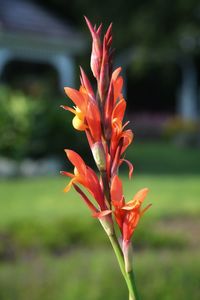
[0,86,33,157]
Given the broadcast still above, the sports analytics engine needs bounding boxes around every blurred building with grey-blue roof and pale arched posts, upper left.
[0,0,85,88]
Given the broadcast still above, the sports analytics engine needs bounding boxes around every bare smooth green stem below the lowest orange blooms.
[108,234,139,300]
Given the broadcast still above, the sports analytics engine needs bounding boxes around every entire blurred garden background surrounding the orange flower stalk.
[0,0,200,300]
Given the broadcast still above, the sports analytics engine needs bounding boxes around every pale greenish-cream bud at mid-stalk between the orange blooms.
[92,142,106,171]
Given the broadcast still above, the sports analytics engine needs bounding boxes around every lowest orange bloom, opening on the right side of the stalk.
[111,175,151,243]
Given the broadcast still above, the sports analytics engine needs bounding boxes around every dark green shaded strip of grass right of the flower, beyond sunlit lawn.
[127,141,200,175]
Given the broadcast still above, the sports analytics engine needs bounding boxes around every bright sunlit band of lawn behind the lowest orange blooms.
[0,175,200,227]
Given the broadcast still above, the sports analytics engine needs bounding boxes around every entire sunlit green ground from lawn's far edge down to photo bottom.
[0,174,200,300]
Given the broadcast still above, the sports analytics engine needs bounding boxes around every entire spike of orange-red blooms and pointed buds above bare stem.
[61,18,150,260]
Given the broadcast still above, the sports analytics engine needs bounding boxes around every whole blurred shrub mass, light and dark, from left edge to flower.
[0,86,82,159]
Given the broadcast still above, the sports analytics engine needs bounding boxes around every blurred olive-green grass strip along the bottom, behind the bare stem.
[0,248,200,300]
